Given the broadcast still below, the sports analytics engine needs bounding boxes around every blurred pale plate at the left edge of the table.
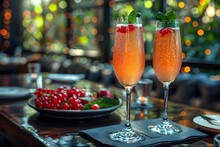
[0,86,31,100]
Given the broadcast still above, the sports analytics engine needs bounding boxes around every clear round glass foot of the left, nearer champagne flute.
[109,128,146,143]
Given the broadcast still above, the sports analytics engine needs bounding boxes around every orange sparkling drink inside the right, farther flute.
[153,30,182,82]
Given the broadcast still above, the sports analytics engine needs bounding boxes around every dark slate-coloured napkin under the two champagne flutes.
[79,119,207,147]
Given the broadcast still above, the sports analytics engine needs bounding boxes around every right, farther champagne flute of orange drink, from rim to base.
[148,21,182,135]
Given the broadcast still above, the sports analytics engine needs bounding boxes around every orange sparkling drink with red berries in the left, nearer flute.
[113,24,145,86]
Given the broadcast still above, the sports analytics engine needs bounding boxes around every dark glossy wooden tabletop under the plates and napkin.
[0,74,217,147]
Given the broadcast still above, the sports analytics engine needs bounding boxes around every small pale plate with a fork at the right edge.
[193,115,220,133]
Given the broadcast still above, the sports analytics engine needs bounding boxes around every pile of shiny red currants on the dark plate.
[34,86,86,110]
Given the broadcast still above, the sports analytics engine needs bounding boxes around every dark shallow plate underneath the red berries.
[28,97,122,119]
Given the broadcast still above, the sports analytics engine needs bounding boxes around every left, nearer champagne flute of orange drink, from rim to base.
[109,14,145,143]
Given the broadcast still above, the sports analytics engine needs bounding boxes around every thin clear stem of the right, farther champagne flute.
[163,82,170,121]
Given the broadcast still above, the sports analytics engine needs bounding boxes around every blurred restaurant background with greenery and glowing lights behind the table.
[0,0,220,112]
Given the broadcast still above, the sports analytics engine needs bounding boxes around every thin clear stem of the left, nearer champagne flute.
[125,86,132,128]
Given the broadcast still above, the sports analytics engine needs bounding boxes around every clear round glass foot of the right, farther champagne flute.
[148,121,182,135]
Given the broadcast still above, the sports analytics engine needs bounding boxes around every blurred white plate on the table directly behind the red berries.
[48,74,85,82]
